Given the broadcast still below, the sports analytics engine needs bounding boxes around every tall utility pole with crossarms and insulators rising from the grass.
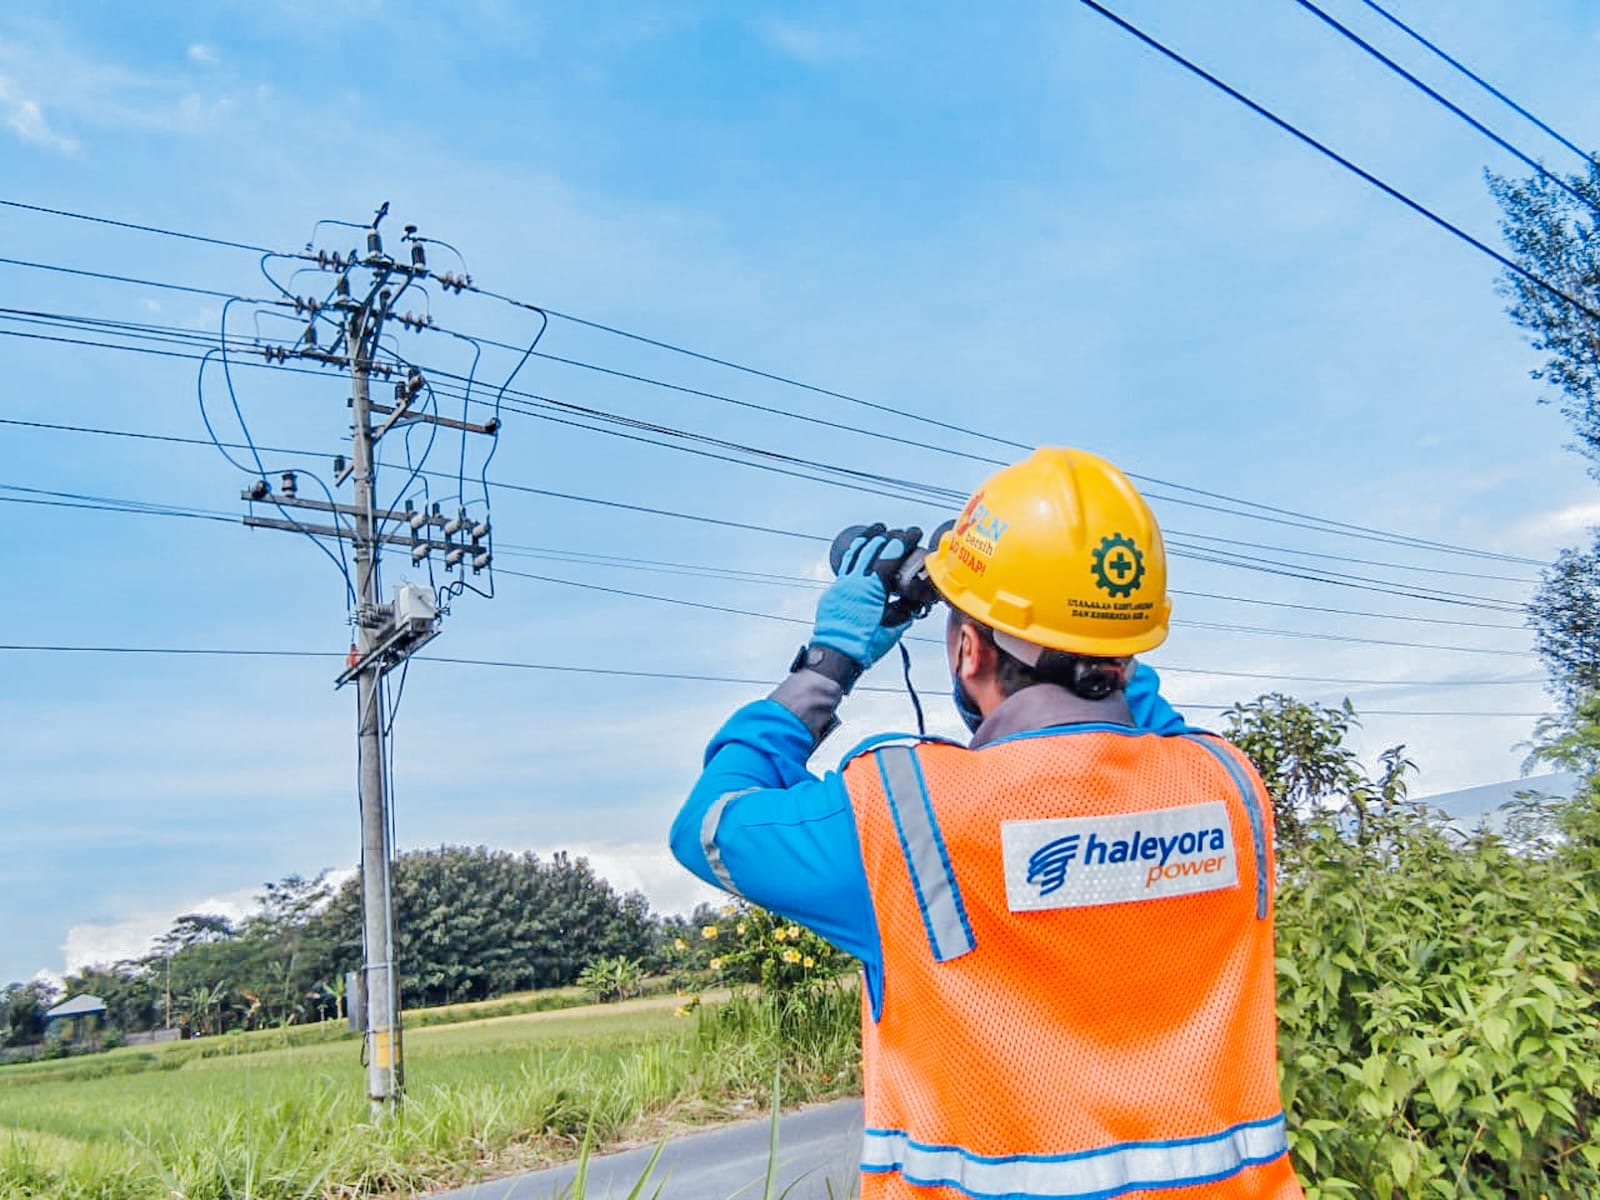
[232,203,499,1118]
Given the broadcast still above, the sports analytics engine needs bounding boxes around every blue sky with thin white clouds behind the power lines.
[0,0,1600,979]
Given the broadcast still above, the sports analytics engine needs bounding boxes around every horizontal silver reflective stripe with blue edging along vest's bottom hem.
[861,1114,1288,1200]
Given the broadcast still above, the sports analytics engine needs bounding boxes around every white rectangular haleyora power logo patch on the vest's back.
[1000,800,1238,912]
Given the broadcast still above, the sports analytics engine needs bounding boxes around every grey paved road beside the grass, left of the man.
[430,1099,861,1200]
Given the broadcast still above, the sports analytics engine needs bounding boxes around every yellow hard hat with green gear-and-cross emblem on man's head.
[928,446,1173,666]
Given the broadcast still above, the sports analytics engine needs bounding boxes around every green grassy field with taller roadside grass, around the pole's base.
[0,990,859,1200]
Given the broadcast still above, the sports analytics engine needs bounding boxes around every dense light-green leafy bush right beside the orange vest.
[1278,802,1600,1200]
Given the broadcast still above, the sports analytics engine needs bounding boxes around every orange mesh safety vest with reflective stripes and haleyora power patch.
[843,725,1302,1200]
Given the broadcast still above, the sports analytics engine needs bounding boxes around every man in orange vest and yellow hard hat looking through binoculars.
[672,450,1302,1200]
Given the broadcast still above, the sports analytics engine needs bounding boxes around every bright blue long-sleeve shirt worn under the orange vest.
[672,664,1189,1011]
